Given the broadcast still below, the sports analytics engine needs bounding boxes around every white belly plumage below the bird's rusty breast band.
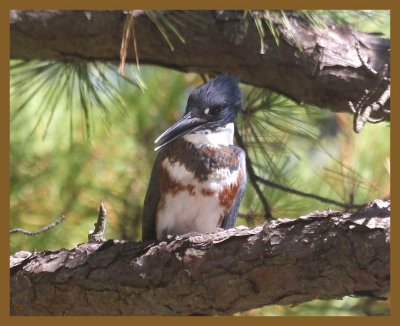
[156,159,238,239]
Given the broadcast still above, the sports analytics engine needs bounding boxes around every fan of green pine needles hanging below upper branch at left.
[10,60,143,137]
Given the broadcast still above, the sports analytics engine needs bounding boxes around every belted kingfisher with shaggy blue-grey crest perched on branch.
[142,75,246,240]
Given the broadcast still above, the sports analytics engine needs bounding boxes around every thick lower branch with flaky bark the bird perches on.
[10,200,390,315]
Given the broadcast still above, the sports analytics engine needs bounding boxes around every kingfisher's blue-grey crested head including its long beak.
[155,75,243,150]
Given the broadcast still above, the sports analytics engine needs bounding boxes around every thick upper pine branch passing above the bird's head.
[10,10,390,117]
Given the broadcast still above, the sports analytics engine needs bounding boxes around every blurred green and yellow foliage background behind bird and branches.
[10,12,390,315]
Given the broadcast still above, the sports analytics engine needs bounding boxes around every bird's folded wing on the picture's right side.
[222,147,247,229]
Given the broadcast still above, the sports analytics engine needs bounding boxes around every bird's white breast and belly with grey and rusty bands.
[156,142,243,239]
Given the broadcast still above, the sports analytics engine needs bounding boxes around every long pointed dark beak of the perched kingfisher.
[154,112,207,151]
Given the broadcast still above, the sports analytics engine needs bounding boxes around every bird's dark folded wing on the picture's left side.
[142,152,162,240]
